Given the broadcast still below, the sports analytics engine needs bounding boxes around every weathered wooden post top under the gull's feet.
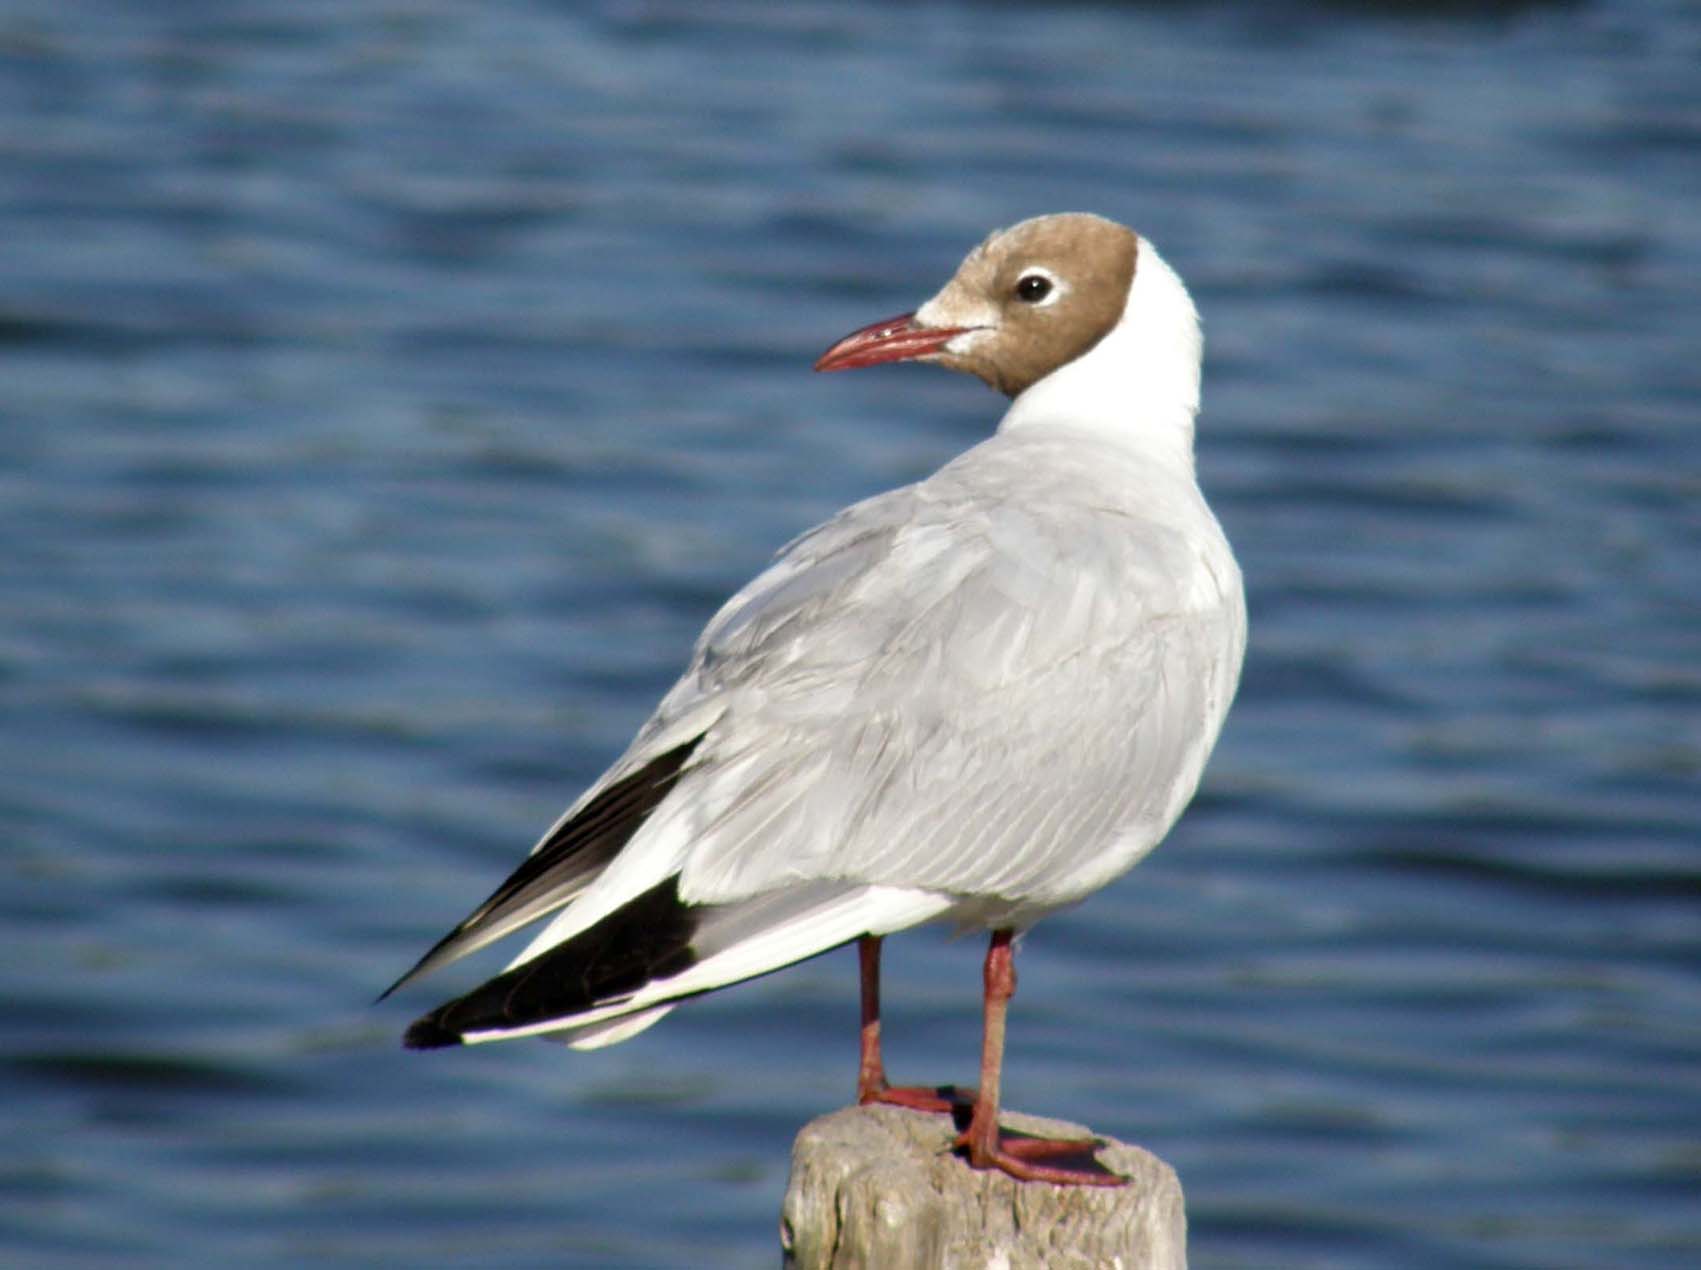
[779,1105,1187,1270]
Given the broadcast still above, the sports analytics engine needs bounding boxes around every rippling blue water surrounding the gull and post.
[0,0,1701,1270]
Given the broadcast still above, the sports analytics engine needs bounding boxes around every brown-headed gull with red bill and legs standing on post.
[384,213,1247,1185]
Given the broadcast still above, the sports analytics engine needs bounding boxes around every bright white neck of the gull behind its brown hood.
[998,238,1203,473]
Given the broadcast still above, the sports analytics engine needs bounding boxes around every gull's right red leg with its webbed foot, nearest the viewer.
[956,930,1128,1187]
